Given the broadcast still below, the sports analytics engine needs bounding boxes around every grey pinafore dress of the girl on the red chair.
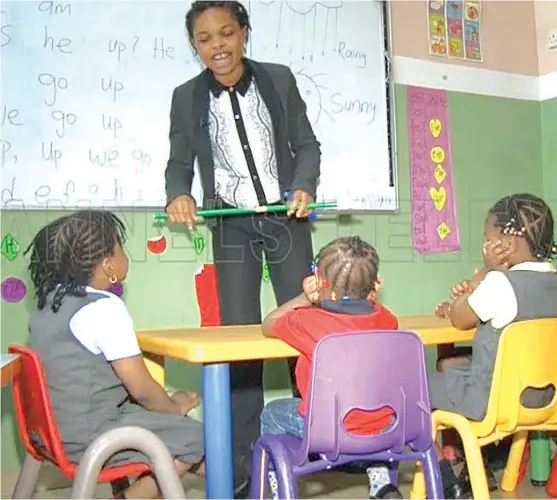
[29,293,203,465]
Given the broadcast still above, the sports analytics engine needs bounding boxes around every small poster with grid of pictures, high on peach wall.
[427,0,482,62]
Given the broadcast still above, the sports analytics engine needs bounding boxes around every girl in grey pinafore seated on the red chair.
[26,210,203,498]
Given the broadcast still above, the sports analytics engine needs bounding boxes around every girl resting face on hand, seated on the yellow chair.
[429,194,557,498]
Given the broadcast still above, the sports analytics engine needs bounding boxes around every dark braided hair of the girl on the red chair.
[25,210,126,312]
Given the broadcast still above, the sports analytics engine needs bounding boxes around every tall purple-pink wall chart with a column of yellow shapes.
[407,87,460,254]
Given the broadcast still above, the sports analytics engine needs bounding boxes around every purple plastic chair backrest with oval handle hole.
[300,330,432,460]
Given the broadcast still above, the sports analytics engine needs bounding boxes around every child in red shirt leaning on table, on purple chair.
[263,236,398,434]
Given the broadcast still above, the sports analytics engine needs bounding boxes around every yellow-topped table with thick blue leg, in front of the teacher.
[137,316,474,498]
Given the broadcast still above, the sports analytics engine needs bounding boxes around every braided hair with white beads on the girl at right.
[489,194,557,261]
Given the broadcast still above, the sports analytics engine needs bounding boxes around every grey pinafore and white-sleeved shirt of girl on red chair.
[29,287,203,464]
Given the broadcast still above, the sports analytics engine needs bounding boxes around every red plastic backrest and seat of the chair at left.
[8,345,151,498]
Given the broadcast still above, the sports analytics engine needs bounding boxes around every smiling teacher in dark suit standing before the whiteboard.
[165,1,321,498]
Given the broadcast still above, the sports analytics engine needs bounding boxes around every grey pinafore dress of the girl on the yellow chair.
[428,271,557,420]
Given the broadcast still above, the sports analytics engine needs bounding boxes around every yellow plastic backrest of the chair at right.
[483,318,557,433]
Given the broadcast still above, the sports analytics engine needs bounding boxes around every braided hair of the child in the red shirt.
[316,236,379,299]
